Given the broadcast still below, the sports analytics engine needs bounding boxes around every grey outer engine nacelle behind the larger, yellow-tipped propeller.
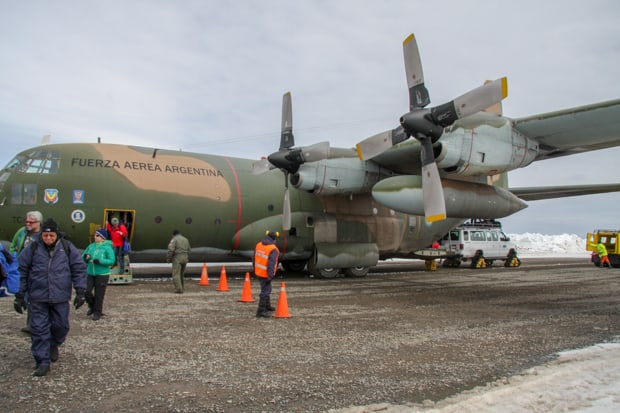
[436,121,539,176]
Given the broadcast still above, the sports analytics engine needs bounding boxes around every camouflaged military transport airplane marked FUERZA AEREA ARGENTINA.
[0,35,620,277]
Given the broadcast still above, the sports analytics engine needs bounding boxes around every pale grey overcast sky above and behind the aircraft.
[0,0,620,236]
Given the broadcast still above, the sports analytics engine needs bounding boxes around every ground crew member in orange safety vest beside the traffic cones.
[252,231,280,317]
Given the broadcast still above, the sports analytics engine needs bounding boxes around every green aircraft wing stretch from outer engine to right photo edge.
[513,99,620,160]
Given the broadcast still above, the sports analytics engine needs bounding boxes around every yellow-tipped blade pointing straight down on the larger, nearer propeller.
[420,137,446,222]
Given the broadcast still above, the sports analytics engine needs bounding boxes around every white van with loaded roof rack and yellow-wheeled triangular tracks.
[441,220,521,268]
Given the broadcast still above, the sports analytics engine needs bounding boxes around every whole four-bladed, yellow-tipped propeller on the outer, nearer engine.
[357,34,508,222]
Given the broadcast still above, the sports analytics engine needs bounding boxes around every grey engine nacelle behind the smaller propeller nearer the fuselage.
[290,158,393,195]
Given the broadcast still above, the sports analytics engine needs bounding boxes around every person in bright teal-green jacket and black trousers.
[82,228,116,321]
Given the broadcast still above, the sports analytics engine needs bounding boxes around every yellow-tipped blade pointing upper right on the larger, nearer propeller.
[431,77,508,127]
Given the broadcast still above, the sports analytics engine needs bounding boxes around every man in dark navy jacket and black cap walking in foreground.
[14,219,86,376]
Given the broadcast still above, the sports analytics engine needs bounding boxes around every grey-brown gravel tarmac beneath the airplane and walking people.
[0,259,620,412]
